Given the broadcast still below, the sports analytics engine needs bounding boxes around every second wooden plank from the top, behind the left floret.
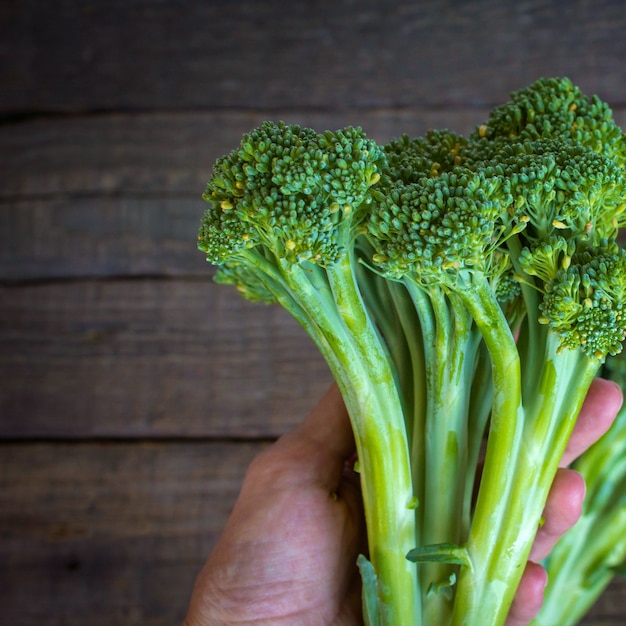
[0,110,626,281]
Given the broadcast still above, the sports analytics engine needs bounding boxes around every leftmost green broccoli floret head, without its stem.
[200,122,384,265]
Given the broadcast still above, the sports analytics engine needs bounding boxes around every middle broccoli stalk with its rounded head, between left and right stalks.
[369,165,519,623]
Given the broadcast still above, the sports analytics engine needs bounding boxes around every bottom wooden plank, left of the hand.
[0,443,626,626]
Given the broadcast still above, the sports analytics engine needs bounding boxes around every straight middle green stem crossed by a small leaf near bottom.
[420,287,475,624]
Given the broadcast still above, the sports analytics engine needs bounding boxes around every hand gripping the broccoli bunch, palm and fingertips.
[184,380,622,626]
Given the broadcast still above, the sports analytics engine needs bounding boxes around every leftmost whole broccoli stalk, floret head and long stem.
[199,123,420,624]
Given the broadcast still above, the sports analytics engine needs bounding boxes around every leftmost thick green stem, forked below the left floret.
[282,256,421,626]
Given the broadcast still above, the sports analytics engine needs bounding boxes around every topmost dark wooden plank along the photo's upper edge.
[0,0,626,114]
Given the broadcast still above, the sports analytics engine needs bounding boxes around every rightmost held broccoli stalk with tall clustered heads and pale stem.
[446,80,625,624]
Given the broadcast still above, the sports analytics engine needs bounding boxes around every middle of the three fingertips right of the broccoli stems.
[530,468,585,561]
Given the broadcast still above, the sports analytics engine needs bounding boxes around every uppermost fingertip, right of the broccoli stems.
[560,378,622,467]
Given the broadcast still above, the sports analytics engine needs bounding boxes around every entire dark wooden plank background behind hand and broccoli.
[0,0,626,626]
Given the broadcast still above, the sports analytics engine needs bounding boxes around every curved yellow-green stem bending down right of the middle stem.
[452,276,524,626]
